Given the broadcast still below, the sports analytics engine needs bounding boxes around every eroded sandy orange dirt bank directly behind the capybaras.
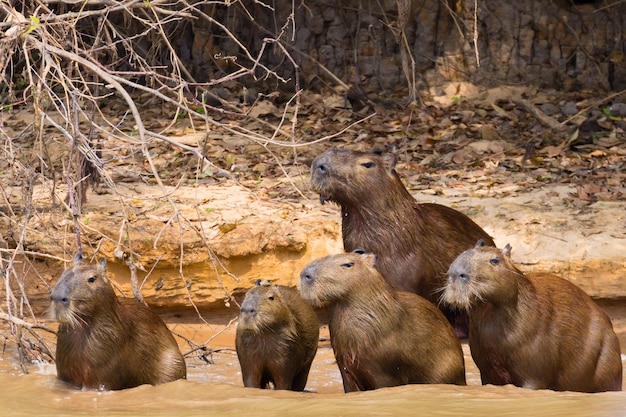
[4,176,626,318]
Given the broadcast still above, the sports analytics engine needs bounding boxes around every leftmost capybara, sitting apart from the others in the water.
[50,254,187,390]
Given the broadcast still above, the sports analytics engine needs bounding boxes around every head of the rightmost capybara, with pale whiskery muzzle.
[442,240,521,310]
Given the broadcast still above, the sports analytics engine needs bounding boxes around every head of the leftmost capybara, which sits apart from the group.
[50,254,117,327]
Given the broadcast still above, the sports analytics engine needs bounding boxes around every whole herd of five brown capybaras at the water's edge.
[50,149,622,392]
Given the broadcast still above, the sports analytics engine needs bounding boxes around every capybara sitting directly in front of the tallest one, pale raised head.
[300,251,465,392]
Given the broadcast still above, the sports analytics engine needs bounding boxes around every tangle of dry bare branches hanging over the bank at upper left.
[0,0,371,370]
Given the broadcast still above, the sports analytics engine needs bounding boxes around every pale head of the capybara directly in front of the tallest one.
[300,249,378,306]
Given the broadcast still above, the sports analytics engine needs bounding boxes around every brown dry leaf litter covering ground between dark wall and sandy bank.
[2,88,626,205]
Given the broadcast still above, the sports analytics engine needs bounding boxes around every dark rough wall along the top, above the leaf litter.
[182,0,626,95]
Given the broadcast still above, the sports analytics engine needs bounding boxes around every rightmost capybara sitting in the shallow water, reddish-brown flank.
[443,242,622,392]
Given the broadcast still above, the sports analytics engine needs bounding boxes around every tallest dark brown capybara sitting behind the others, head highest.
[311,149,495,336]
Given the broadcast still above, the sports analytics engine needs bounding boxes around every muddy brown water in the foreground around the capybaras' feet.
[0,302,626,417]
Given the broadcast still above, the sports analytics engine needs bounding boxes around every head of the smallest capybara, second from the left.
[237,280,293,333]
